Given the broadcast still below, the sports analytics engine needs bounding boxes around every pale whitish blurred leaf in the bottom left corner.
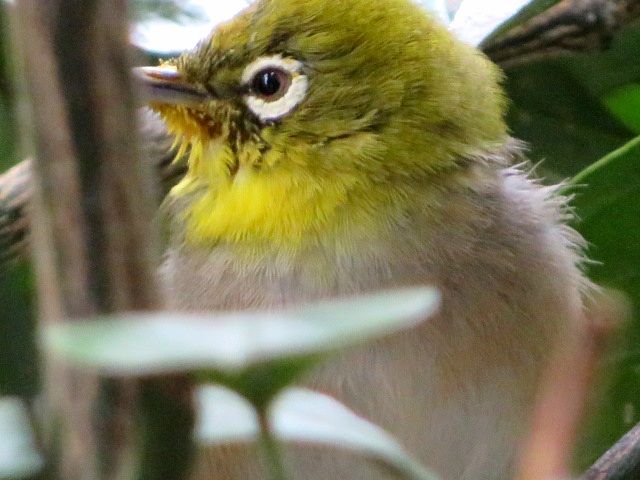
[0,397,44,479]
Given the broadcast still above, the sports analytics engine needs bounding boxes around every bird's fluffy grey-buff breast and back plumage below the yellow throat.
[165,141,590,480]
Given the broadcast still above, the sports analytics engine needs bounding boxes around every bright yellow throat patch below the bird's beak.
[156,107,384,250]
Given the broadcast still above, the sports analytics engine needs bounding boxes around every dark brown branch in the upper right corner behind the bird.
[482,0,640,67]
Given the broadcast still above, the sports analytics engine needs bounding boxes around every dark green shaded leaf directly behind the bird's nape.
[506,60,634,180]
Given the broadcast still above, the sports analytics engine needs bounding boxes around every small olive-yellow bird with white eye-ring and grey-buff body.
[137,0,590,480]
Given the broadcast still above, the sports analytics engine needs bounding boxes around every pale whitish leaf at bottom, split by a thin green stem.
[196,386,436,480]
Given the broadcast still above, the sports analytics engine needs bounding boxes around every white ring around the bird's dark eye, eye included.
[242,55,309,122]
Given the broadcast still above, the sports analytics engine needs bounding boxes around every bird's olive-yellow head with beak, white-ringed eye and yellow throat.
[138,0,506,253]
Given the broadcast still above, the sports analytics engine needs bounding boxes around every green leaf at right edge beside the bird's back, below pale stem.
[572,137,640,466]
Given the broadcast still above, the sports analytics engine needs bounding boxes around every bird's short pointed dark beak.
[133,65,212,106]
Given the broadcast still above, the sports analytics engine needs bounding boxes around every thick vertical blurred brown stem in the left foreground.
[12,0,193,480]
